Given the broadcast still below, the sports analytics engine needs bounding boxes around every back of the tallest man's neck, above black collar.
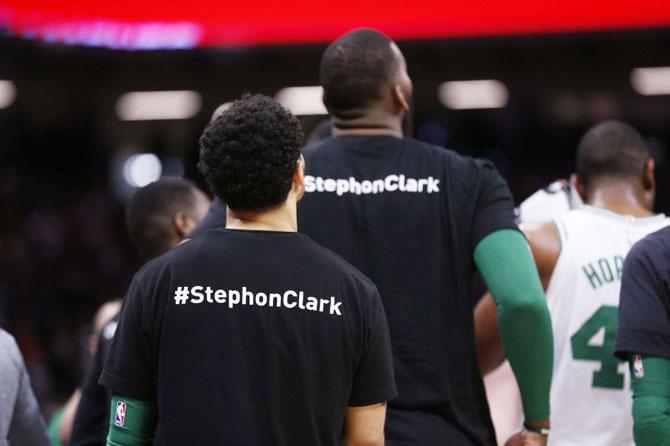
[333,109,403,138]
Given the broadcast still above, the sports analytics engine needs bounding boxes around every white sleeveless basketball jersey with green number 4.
[547,206,670,446]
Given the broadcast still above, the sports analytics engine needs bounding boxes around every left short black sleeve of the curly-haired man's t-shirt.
[99,275,155,400]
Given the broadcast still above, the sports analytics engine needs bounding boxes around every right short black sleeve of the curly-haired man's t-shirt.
[348,290,398,407]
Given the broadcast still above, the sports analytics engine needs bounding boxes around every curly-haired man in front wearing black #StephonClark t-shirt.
[101,96,396,445]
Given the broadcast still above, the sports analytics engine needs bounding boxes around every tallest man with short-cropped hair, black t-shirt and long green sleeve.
[298,29,552,445]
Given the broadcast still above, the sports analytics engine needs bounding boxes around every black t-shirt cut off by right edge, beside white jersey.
[614,227,670,359]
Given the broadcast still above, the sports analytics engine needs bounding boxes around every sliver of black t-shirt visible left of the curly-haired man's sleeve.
[70,314,119,446]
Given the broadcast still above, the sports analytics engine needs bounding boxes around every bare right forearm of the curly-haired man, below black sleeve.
[344,403,386,446]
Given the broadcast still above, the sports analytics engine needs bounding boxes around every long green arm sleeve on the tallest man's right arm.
[475,229,554,422]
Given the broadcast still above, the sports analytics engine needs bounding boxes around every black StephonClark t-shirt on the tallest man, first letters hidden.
[298,136,516,445]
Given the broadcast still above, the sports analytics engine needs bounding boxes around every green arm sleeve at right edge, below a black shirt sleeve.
[629,355,670,446]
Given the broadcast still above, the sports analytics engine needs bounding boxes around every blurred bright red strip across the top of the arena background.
[0,0,670,48]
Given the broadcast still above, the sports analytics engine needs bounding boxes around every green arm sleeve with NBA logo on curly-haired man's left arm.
[107,395,158,446]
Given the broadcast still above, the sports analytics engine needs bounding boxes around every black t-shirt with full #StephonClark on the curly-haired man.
[100,229,396,445]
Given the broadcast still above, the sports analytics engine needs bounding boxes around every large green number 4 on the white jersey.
[570,305,624,389]
